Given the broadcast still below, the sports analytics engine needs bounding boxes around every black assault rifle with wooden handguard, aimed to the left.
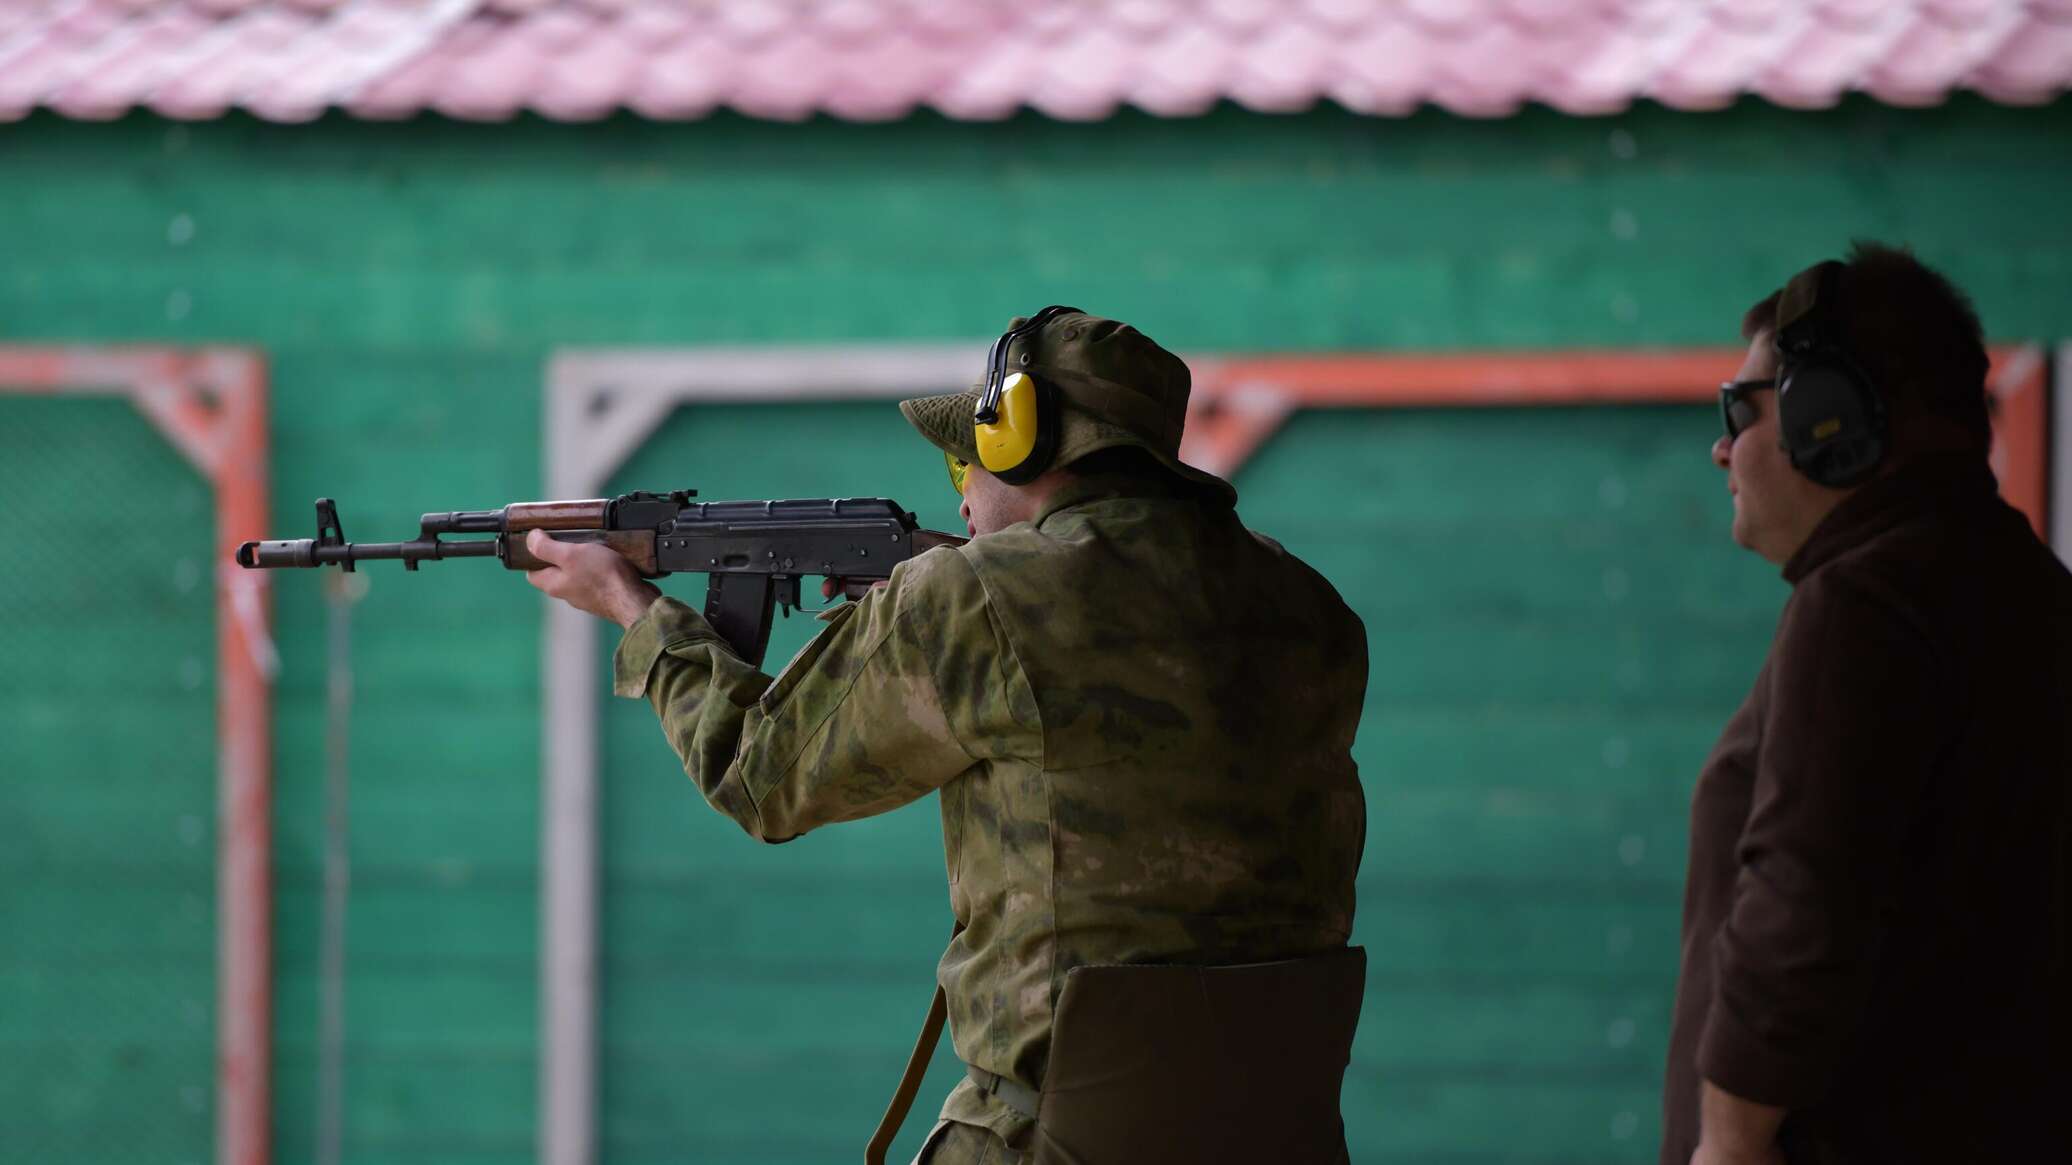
[238,489,963,665]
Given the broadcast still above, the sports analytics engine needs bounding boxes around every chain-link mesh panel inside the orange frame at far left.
[0,392,215,1165]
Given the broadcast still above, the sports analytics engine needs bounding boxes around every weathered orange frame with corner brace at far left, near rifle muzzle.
[0,344,276,1165]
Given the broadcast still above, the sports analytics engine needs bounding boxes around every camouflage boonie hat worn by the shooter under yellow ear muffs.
[899,313,1237,506]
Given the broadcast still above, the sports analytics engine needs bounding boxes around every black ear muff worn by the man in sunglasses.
[1776,259,1888,489]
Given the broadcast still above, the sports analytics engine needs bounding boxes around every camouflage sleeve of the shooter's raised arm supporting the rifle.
[613,551,992,842]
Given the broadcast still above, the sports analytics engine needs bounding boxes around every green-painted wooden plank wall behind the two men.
[0,100,2072,1165]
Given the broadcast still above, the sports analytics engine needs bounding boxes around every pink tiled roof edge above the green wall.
[0,0,2072,120]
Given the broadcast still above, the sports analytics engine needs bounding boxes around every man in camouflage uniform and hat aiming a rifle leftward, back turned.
[528,313,1368,1163]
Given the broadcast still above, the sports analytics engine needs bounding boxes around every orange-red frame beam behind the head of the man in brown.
[1181,344,2049,537]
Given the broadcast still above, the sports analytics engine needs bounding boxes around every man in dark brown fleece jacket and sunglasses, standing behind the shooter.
[1662,245,2072,1165]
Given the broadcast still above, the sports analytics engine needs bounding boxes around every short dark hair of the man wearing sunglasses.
[1740,240,1993,448]
